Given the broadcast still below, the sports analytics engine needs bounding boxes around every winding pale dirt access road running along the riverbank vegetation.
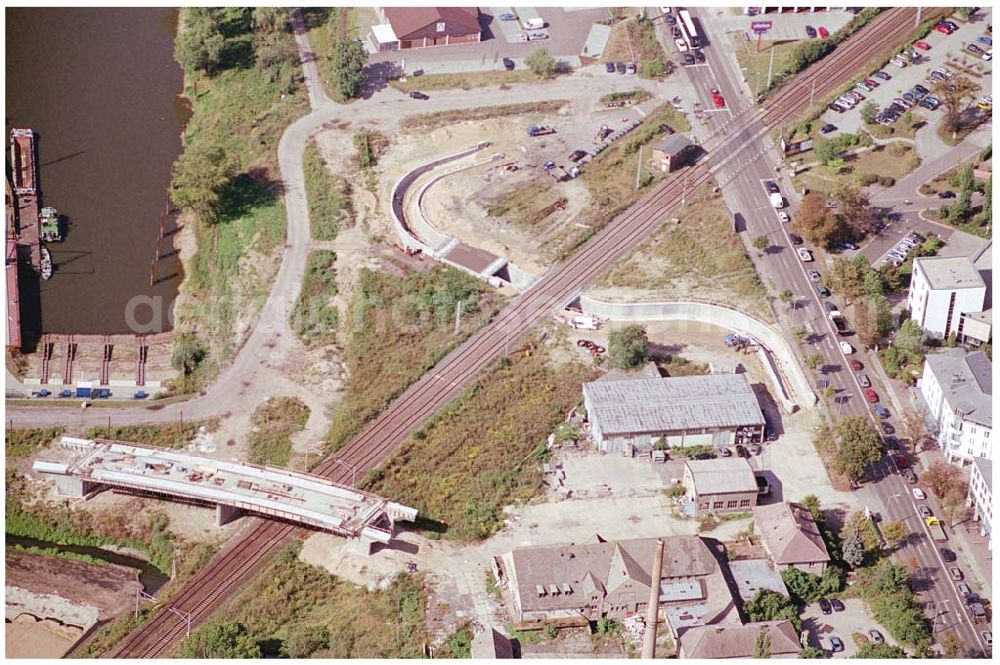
[7,13,666,428]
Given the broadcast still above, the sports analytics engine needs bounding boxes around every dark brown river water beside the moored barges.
[4,8,190,339]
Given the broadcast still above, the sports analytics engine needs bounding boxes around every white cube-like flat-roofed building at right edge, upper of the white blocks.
[907,256,989,341]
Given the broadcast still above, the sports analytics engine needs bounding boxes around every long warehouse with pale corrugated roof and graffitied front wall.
[583,374,764,456]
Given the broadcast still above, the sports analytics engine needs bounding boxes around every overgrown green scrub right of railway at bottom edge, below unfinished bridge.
[181,548,427,658]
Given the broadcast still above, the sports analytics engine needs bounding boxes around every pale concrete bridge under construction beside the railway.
[33,437,417,550]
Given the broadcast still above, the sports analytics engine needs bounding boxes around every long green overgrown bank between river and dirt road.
[171,7,306,374]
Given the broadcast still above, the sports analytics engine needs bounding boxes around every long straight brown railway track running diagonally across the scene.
[111,8,916,658]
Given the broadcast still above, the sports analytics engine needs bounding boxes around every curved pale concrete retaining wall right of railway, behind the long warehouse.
[580,295,816,412]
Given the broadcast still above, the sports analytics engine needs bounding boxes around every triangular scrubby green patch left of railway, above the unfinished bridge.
[327,266,499,452]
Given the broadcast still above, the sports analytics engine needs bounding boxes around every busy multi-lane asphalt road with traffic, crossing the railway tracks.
[687,10,987,655]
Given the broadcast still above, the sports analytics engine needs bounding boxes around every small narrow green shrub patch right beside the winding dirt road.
[290,249,340,346]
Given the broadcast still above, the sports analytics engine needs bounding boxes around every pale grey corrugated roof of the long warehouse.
[583,374,764,435]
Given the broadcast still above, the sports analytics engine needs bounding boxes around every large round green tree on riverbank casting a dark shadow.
[170,141,239,223]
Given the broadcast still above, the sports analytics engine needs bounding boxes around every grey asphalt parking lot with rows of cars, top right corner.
[822,9,993,132]
